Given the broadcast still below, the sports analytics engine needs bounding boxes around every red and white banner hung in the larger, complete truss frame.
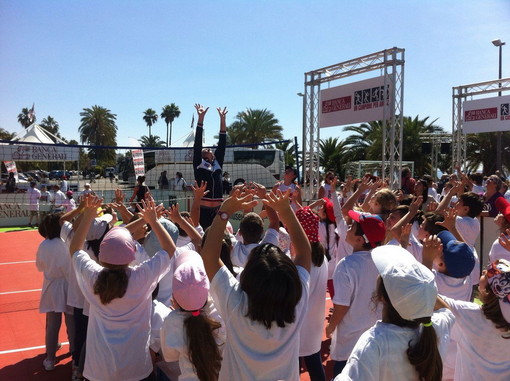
[319,76,392,127]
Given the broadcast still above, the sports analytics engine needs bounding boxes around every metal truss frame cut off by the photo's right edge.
[452,78,510,172]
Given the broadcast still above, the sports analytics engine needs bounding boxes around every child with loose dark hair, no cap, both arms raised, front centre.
[202,189,311,381]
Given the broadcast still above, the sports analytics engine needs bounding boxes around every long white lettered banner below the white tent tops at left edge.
[0,144,80,161]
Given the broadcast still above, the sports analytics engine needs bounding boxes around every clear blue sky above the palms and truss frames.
[0,0,510,145]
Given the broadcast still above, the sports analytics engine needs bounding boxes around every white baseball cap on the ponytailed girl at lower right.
[371,245,437,320]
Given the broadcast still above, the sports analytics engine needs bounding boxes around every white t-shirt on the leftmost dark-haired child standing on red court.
[35,237,72,313]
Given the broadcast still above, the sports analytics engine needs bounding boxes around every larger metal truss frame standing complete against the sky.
[303,47,405,200]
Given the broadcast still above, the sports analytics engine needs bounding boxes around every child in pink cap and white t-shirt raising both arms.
[69,197,175,381]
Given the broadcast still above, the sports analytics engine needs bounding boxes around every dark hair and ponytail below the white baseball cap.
[372,276,443,381]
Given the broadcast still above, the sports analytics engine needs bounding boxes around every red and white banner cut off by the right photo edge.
[462,95,510,134]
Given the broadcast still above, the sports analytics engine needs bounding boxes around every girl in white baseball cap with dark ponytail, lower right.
[335,243,455,381]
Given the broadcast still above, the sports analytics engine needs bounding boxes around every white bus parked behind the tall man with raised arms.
[145,147,285,189]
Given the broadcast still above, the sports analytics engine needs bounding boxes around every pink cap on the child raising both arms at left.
[99,227,136,265]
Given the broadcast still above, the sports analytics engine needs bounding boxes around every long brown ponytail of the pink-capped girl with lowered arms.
[184,311,221,381]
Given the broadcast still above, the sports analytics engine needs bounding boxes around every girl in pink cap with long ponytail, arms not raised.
[161,250,225,381]
